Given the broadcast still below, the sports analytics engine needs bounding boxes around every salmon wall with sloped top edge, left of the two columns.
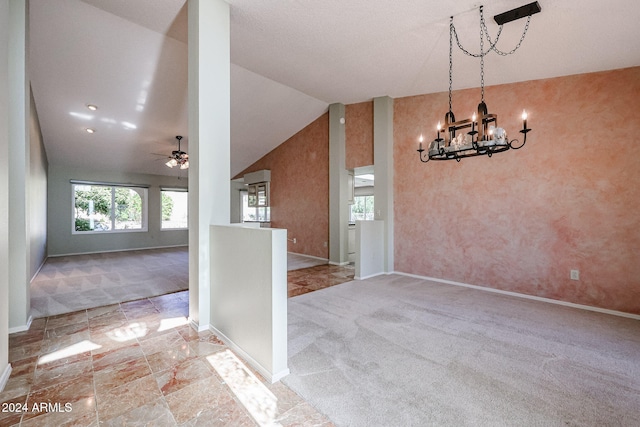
[236,113,329,258]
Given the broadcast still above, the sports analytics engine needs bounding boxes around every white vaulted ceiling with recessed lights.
[29,0,640,175]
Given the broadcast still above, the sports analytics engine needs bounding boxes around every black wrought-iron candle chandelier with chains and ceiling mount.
[418,2,541,163]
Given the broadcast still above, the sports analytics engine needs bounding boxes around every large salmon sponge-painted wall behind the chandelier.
[394,67,640,314]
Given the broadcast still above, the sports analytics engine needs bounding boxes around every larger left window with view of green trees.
[72,183,147,233]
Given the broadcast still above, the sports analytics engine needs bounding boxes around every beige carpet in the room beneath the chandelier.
[283,275,640,427]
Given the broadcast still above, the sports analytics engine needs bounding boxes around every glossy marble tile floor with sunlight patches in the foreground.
[0,291,333,427]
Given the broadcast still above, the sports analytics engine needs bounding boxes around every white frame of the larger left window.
[70,180,149,235]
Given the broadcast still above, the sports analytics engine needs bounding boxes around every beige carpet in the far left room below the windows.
[31,247,189,318]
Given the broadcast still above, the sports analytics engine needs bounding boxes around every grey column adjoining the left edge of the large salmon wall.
[373,96,394,273]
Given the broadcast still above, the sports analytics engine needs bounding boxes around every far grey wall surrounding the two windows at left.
[47,165,191,256]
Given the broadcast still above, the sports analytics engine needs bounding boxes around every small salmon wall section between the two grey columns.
[344,101,373,169]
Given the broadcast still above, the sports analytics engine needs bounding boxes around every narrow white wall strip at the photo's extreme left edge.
[0,0,11,391]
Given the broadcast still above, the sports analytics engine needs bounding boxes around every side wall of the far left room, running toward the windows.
[27,89,49,279]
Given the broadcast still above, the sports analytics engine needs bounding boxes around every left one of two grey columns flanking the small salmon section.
[329,104,349,265]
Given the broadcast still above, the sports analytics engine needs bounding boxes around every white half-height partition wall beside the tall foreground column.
[211,225,289,382]
